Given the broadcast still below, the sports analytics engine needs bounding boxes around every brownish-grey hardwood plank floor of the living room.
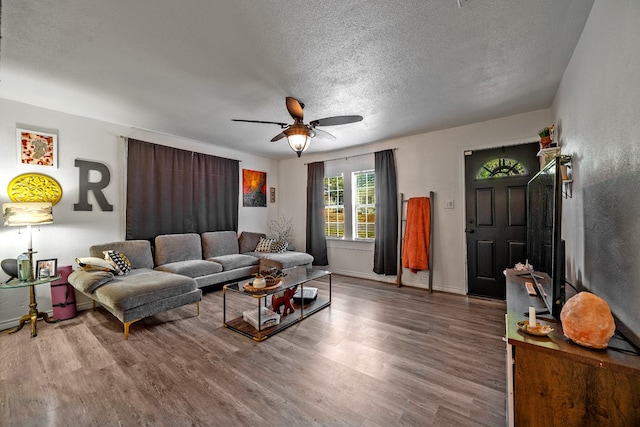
[0,275,506,426]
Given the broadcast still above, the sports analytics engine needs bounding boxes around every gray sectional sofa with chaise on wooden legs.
[69,231,313,338]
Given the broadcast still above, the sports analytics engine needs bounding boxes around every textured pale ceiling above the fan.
[0,0,593,159]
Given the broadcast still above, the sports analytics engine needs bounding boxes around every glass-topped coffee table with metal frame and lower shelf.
[222,267,331,341]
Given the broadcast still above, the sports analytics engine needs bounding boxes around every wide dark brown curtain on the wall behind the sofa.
[126,139,240,240]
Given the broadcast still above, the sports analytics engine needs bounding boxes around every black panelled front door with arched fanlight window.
[465,142,540,299]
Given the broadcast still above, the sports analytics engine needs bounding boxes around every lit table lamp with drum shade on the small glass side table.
[2,202,53,282]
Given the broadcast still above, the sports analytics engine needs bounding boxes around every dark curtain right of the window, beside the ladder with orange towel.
[373,150,398,275]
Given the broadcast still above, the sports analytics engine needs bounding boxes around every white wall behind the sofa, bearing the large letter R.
[0,99,278,330]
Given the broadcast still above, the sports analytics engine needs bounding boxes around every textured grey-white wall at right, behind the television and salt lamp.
[552,0,640,334]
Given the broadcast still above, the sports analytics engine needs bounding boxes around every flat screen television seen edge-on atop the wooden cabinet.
[527,156,565,319]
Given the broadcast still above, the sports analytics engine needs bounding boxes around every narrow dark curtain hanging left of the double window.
[307,162,329,265]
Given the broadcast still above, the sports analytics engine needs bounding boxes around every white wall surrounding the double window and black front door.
[279,110,551,294]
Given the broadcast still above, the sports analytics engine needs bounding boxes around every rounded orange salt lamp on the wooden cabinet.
[560,292,616,349]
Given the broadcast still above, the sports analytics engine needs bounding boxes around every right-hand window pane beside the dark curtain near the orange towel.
[351,170,376,239]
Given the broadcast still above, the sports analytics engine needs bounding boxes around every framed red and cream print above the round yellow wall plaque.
[16,129,58,168]
